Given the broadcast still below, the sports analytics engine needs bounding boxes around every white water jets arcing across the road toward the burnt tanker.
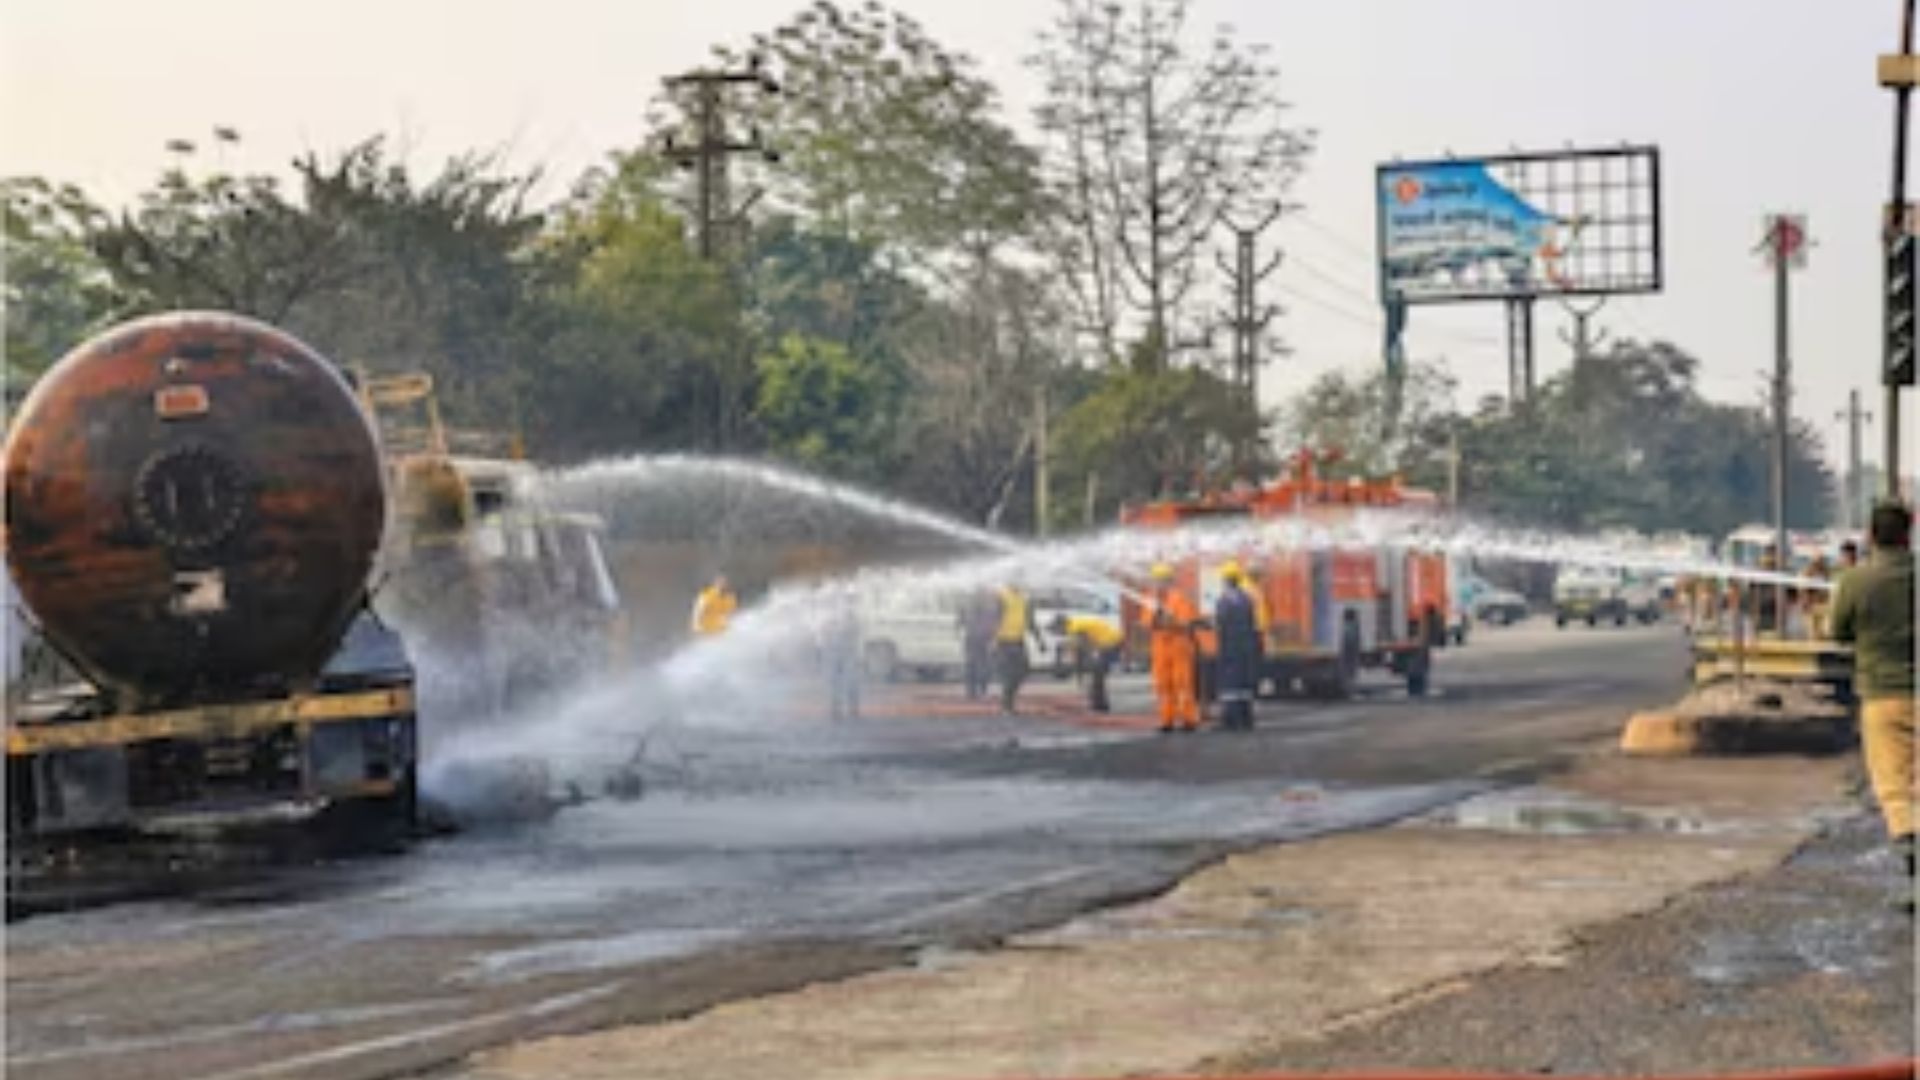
[428,455,1828,803]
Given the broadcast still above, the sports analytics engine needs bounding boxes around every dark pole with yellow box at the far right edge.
[1880,0,1920,500]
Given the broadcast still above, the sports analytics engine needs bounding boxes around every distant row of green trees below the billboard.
[1288,342,1834,536]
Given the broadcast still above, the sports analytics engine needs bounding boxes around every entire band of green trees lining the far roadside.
[0,0,1832,534]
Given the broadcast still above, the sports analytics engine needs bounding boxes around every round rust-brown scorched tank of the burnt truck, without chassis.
[4,311,386,707]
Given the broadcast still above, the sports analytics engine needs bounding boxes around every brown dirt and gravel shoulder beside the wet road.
[459,753,1881,1080]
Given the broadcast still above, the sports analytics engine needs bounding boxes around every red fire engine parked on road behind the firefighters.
[1121,452,1448,698]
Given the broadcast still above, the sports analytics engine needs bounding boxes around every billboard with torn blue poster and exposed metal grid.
[1375,146,1661,304]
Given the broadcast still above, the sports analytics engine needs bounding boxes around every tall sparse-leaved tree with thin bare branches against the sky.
[1033,0,1311,371]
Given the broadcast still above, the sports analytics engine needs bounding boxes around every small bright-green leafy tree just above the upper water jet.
[755,334,900,480]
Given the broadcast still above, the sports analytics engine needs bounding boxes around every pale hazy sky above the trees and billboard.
[0,0,1920,463]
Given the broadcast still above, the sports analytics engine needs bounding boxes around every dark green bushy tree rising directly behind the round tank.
[72,138,541,427]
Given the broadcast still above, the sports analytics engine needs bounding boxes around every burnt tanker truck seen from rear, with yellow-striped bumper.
[4,311,417,853]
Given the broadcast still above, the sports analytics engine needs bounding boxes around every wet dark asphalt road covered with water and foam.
[6,621,1684,1080]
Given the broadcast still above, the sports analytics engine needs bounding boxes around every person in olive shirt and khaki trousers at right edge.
[1832,503,1914,876]
